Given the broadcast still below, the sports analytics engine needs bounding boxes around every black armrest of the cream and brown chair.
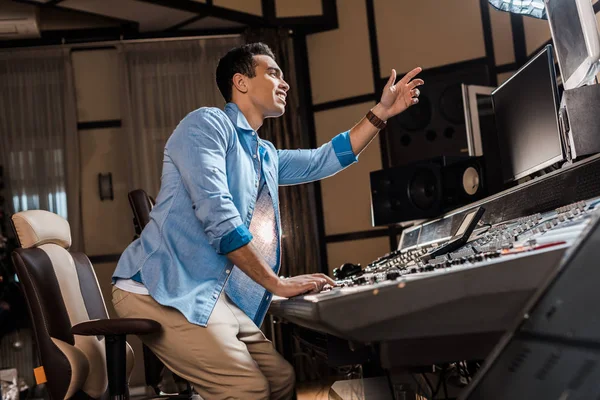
[71,318,161,336]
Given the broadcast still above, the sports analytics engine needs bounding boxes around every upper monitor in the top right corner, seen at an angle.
[544,0,600,89]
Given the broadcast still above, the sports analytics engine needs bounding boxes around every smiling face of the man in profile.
[248,55,290,118]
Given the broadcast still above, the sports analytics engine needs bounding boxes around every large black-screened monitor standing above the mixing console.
[492,45,564,182]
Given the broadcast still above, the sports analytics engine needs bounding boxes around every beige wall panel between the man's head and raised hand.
[307,0,375,104]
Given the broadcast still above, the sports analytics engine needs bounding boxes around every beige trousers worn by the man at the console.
[112,287,295,400]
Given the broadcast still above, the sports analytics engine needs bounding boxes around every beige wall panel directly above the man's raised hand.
[374,0,485,77]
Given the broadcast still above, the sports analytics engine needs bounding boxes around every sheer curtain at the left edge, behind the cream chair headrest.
[0,49,83,250]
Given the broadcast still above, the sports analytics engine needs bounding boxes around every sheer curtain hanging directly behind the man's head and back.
[119,37,242,196]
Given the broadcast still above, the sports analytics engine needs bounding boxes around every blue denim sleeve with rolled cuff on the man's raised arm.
[277,131,358,185]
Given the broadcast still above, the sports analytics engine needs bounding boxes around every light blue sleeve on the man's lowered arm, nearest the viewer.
[167,109,252,254]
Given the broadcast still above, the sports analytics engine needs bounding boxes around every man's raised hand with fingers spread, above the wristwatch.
[377,67,425,119]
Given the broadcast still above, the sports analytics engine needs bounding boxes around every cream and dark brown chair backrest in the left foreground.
[11,210,133,399]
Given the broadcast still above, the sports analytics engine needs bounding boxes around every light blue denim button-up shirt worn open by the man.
[113,103,357,326]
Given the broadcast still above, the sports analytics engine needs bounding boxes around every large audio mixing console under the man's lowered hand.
[269,195,600,348]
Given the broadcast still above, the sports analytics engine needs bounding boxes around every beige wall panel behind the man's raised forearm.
[315,103,381,235]
